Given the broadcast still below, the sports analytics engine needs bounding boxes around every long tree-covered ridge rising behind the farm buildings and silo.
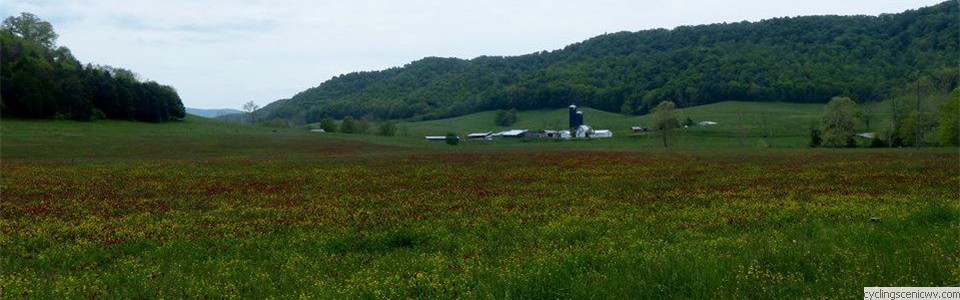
[261,1,960,122]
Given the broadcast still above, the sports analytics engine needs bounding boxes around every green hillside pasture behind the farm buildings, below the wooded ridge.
[400,98,943,149]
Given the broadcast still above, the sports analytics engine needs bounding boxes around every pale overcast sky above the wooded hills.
[2,0,942,108]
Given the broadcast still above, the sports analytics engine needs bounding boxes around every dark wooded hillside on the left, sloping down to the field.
[0,13,185,122]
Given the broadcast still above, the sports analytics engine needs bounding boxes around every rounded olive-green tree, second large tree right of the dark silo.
[822,97,860,147]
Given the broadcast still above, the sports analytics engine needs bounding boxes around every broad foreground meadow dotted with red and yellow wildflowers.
[0,111,960,298]
